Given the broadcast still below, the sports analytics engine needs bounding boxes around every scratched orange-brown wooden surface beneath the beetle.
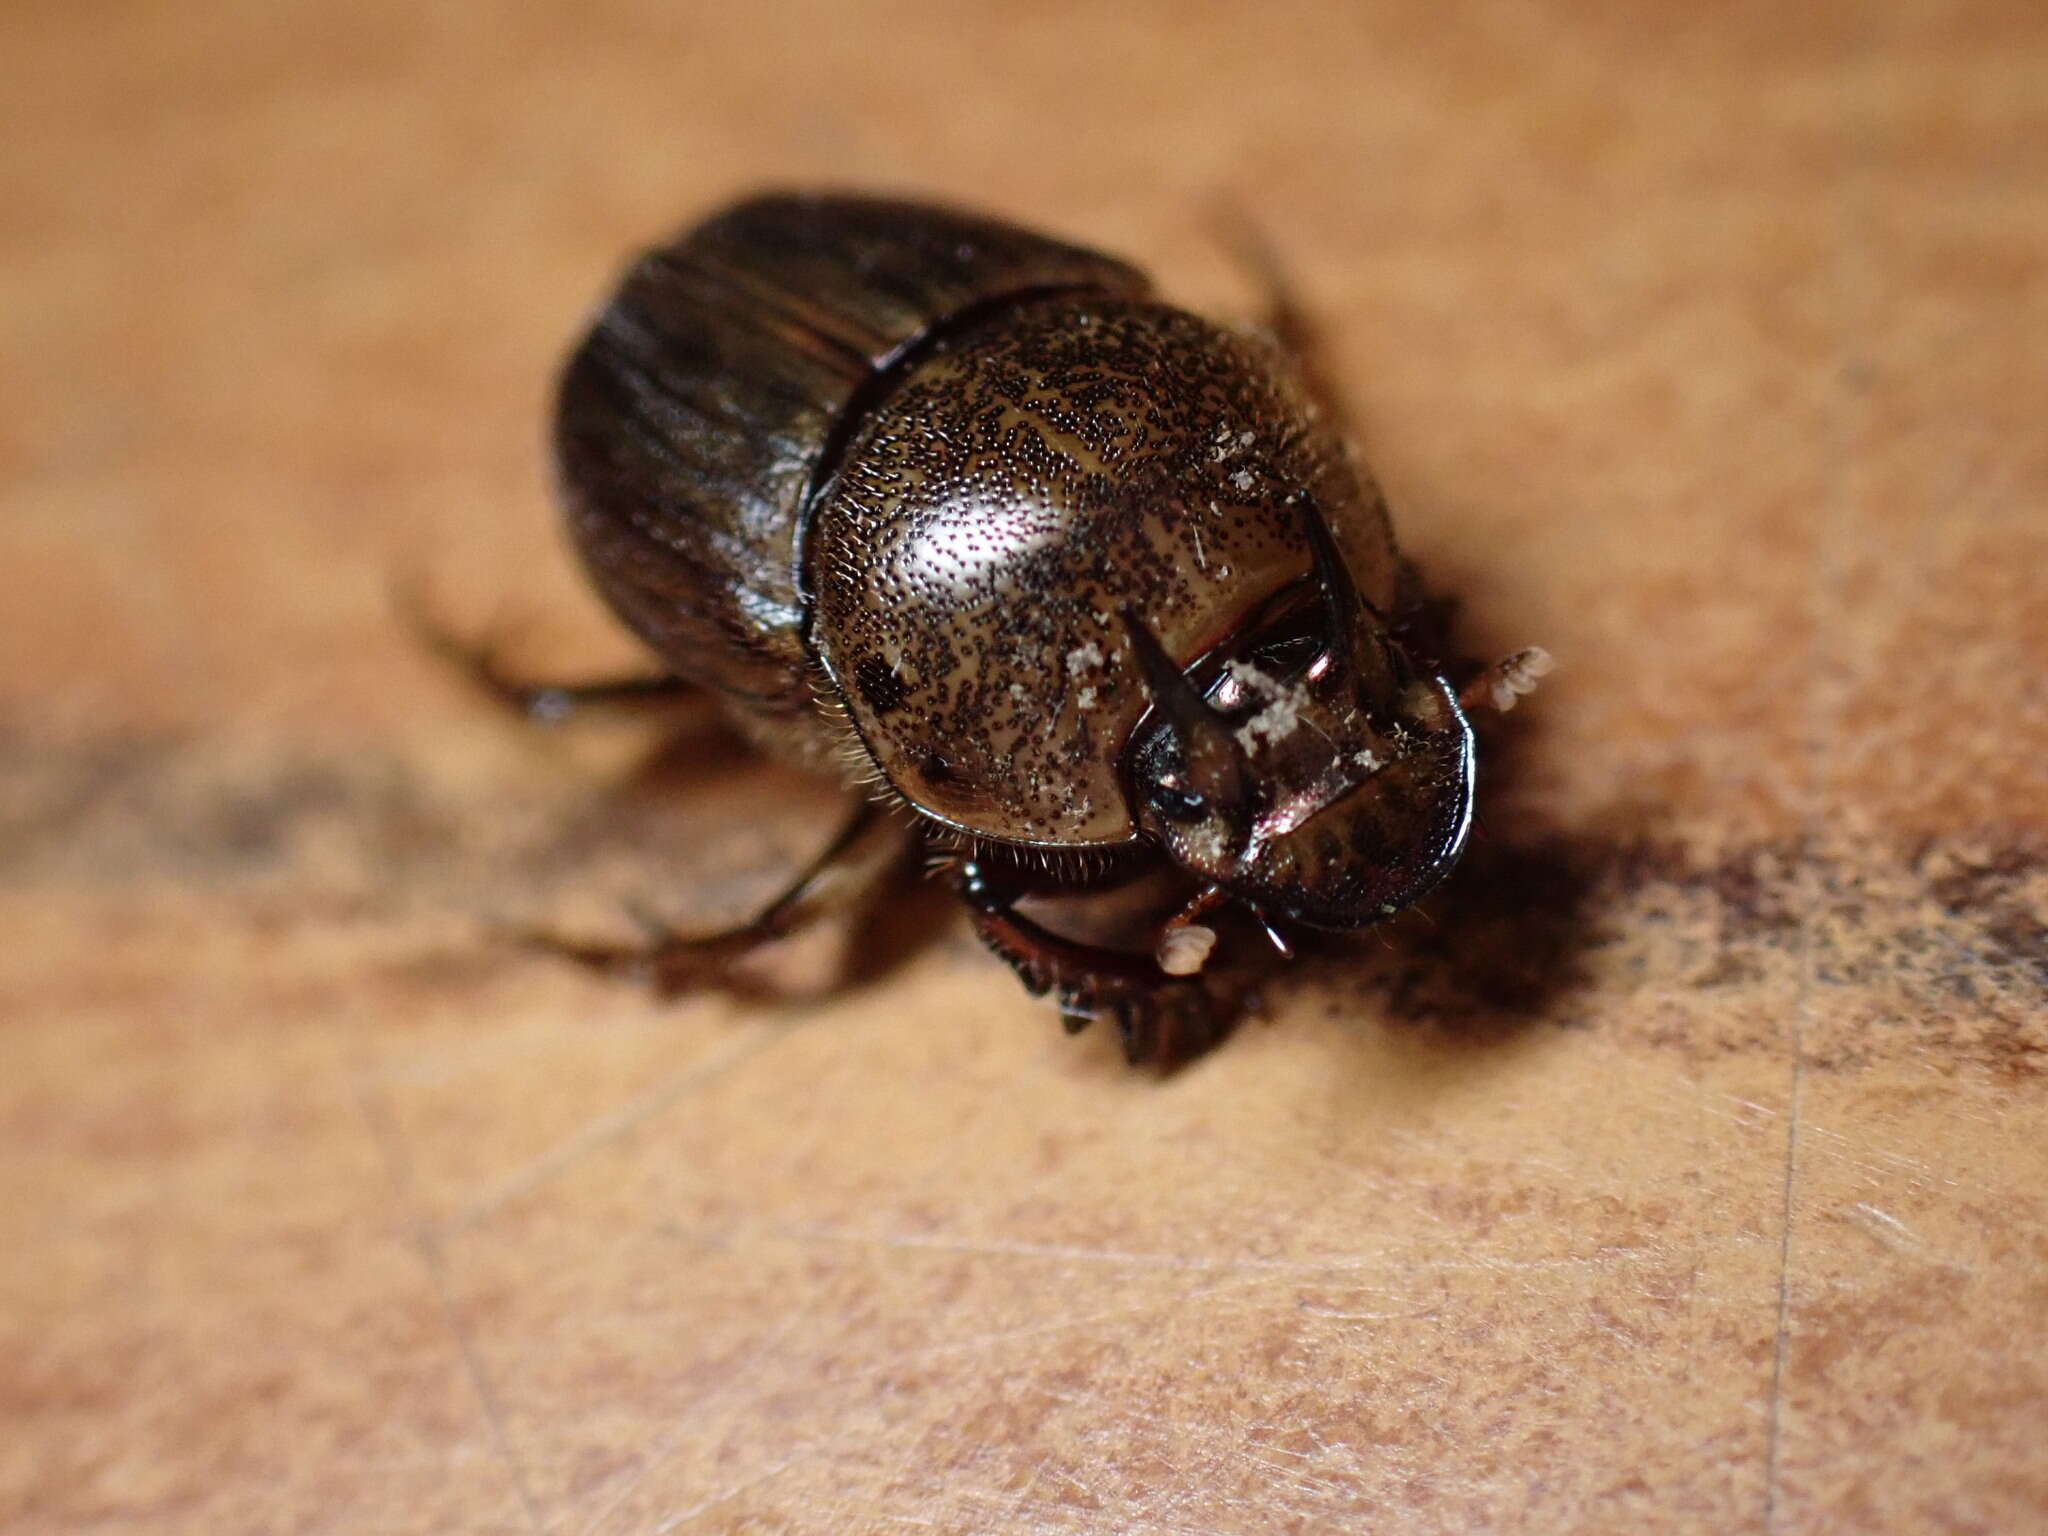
[0,0,2048,1532]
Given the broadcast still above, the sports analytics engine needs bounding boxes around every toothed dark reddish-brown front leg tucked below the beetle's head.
[958,860,1231,1067]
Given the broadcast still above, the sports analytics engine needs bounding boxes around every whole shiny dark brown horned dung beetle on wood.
[499,195,1544,1061]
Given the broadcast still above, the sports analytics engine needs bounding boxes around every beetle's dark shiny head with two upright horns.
[1122,498,1473,930]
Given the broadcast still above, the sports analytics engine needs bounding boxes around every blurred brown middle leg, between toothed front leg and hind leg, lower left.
[520,801,909,997]
